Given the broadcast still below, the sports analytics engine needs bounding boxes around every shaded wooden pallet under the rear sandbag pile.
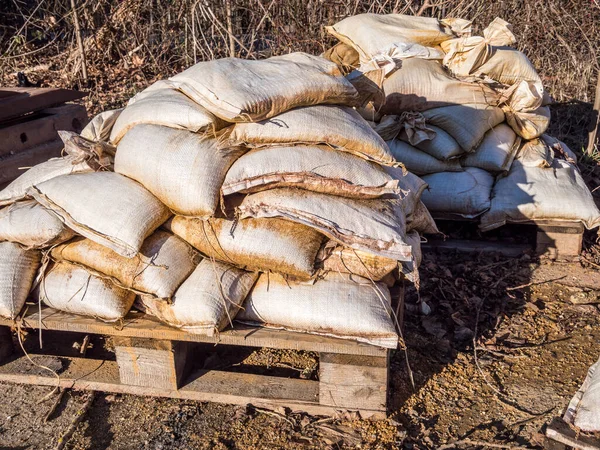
[423,214,584,259]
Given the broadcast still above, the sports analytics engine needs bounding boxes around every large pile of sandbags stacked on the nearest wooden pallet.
[0,53,436,348]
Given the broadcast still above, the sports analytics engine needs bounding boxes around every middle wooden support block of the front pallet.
[114,337,191,391]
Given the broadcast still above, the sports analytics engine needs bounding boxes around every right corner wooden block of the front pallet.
[319,351,390,413]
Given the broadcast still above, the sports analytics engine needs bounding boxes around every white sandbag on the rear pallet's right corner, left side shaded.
[480,159,600,231]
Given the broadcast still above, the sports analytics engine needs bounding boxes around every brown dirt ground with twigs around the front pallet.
[0,246,600,449]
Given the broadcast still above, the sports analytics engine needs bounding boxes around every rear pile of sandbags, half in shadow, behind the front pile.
[324,14,600,230]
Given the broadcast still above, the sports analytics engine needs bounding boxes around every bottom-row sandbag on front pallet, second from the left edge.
[37,262,135,322]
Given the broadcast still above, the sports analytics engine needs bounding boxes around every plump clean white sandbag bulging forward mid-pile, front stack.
[115,125,245,217]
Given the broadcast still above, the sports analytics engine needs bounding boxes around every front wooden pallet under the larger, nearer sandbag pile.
[0,298,404,418]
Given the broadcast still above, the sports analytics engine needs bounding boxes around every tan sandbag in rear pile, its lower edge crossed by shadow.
[380,58,500,114]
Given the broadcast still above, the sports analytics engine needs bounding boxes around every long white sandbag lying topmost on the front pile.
[171,52,358,122]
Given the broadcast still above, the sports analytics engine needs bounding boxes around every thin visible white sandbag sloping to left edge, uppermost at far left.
[0,156,94,206]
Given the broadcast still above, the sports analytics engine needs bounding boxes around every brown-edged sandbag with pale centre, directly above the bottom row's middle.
[168,216,324,279]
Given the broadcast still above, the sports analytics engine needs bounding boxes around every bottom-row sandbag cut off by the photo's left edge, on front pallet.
[0,242,42,319]
